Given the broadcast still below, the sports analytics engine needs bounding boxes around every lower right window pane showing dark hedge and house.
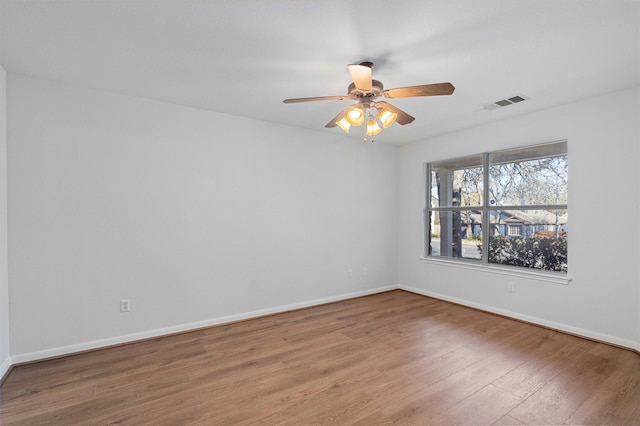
[489,210,568,272]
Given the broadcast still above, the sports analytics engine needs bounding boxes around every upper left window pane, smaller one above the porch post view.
[430,156,483,207]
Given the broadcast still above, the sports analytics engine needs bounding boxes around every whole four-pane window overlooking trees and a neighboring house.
[424,141,568,272]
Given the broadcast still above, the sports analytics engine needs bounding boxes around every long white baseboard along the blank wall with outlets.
[12,285,398,364]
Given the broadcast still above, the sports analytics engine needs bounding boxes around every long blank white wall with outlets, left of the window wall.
[7,74,398,362]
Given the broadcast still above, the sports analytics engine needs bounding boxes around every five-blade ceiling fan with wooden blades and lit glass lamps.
[283,62,455,141]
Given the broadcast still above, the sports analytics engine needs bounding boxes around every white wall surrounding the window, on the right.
[398,88,640,349]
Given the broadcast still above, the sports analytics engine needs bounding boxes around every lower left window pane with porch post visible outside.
[427,210,482,261]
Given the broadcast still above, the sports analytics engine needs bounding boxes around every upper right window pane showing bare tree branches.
[489,142,568,206]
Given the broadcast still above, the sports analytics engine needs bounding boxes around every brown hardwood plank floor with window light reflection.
[0,290,640,425]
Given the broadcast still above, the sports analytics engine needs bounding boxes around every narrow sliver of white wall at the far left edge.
[0,66,11,378]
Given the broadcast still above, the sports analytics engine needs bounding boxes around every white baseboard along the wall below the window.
[398,285,640,352]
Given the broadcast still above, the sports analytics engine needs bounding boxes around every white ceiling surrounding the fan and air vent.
[0,0,640,144]
